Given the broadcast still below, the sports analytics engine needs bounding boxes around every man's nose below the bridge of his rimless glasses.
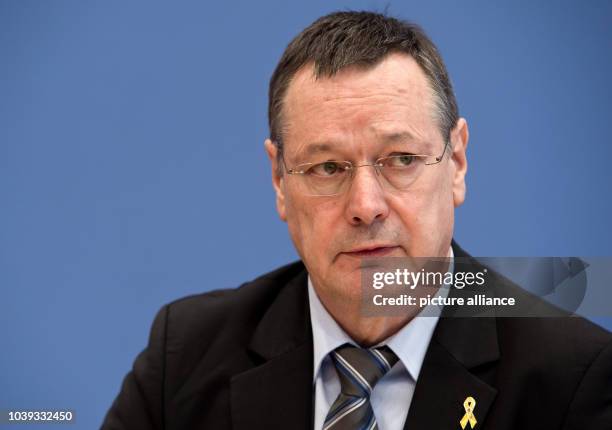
[345,166,389,225]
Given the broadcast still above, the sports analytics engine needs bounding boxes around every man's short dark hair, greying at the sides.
[268,11,459,164]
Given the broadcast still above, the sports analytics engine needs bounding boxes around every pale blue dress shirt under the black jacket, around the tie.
[308,249,453,430]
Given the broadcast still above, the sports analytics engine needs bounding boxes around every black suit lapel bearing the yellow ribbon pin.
[404,242,499,430]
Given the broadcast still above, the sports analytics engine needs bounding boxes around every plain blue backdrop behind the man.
[0,0,612,428]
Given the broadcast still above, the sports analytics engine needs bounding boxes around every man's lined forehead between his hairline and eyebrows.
[283,53,439,155]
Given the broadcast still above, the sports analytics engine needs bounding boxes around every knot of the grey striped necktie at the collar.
[331,343,398,397]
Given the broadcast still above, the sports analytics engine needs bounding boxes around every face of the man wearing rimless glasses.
[266,54,467,302]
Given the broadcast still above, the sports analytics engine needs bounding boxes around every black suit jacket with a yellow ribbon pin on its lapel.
[102,244,612,430]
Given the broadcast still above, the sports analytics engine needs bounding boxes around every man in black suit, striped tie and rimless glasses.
[103,12,612,430]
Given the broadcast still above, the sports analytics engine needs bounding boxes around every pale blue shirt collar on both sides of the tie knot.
[308,248,454,381]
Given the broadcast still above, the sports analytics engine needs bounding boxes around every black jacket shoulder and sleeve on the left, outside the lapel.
[103,262,306,428]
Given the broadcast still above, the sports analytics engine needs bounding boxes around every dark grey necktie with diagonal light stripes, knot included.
[323,343,398,430]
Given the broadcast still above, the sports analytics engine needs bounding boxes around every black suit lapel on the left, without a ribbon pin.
[230,270,313,430]
